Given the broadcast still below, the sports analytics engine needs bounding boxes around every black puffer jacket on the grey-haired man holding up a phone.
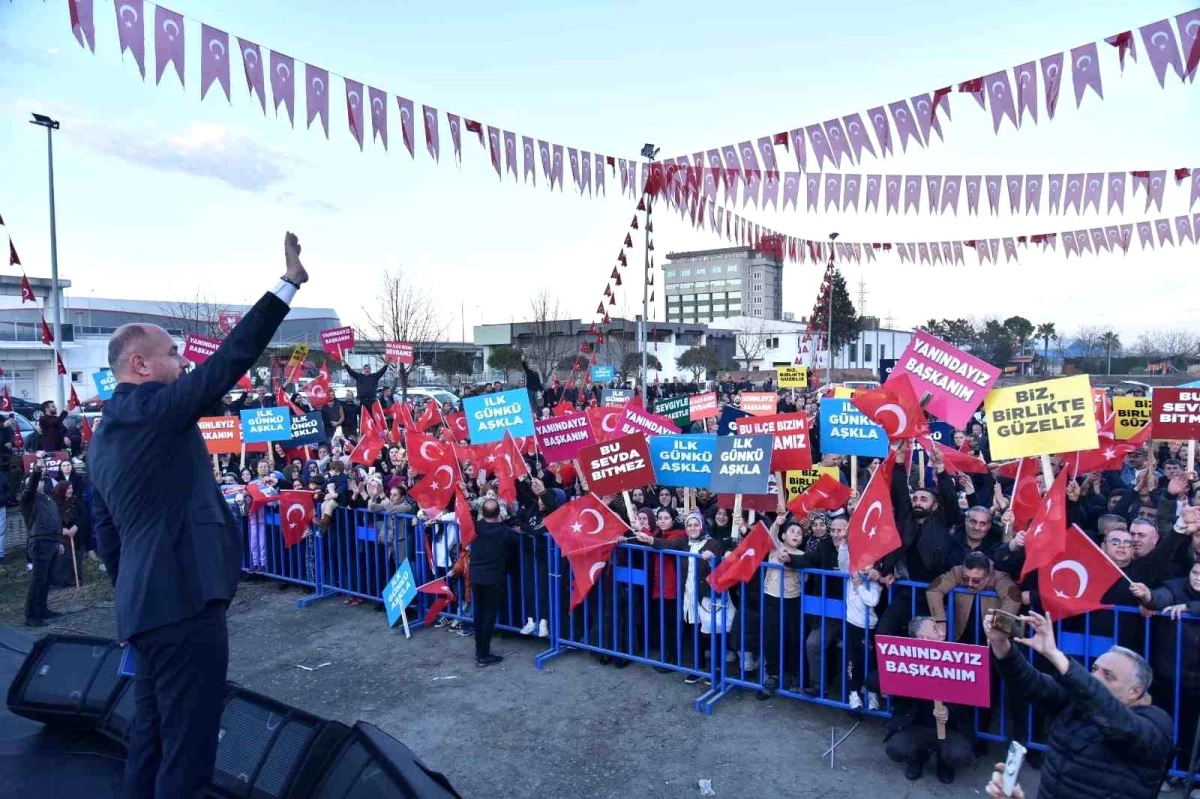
[996,650,1171,799]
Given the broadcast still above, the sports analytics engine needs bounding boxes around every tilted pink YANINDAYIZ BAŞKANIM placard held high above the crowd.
[896,330,1000,427]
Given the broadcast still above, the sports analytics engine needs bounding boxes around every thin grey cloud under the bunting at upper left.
[64,121,295,193]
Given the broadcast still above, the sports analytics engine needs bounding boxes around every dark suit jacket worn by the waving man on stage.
[88,294,288,642]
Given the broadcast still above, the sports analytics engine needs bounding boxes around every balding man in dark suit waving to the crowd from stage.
[88,233,308,799]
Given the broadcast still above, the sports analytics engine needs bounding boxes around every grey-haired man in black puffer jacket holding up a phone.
[984,613,1171,799]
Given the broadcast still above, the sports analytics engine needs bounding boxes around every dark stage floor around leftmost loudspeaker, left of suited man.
[0,625,125,799]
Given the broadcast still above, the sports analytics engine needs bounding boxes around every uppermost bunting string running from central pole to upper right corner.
[667,8,1200,181]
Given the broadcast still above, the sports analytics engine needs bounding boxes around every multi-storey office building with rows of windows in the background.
[662,247,784,324]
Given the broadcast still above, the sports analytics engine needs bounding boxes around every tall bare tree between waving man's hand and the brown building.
[356,269,446,401]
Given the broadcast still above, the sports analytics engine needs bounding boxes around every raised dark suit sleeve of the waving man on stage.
[142,293,289,427]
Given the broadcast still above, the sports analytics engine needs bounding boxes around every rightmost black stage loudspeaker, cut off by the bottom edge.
[310,721,461,799]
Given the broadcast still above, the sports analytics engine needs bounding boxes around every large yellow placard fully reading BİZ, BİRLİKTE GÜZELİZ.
[983,374,1099,461]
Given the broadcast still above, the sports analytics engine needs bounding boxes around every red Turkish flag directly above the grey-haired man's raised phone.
[1038,524,1128,621]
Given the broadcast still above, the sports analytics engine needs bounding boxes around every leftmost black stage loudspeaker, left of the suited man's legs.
[7,635,128,729]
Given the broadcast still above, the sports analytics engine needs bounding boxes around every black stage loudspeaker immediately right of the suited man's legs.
[209,683,349,799]
